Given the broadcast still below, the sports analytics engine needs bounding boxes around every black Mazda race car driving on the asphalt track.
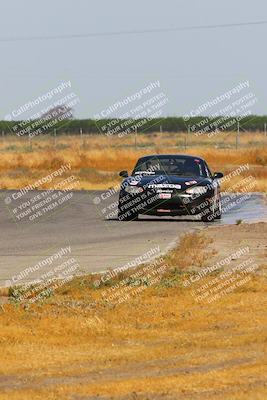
[118,154,223,221]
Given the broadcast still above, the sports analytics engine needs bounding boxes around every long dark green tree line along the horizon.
[0,115,267,136]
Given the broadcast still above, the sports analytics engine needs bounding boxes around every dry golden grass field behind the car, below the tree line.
[0,133,267,192]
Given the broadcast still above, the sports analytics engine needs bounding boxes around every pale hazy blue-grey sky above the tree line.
[0,0,267,119]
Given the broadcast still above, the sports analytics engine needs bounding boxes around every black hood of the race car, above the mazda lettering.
[123,175,212,189]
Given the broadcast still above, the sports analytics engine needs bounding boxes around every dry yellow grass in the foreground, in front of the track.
[0,226,267,400]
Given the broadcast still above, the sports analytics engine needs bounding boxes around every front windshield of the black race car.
[133,156,207,177]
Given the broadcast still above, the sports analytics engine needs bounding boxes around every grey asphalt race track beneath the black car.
[0,190,267,287]
